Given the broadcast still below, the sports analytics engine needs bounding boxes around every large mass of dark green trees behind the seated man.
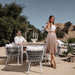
[0,3,45,46]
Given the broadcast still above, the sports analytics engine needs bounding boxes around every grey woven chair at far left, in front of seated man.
[5,46,20,66]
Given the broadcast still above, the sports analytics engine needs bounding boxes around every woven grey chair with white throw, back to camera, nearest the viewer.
[26,46,44,73]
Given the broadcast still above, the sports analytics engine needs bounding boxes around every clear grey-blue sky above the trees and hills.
[0,0,75,30]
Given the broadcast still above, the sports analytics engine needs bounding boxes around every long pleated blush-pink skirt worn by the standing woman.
[46,33,57,54]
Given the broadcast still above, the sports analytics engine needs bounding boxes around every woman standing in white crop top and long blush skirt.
[46,15,57,69]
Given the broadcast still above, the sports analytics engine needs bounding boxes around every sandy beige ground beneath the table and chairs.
[0,47,75,75]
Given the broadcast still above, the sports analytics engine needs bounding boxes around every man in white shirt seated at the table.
[14,31,27,51]
